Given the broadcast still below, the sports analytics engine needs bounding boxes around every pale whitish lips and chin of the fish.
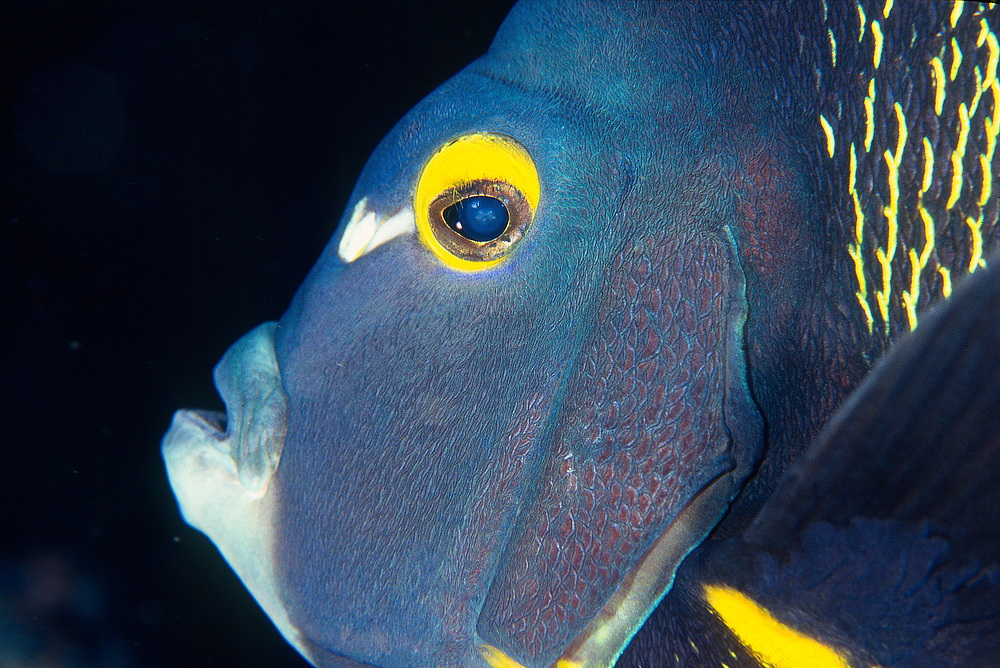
[162,322,311,660]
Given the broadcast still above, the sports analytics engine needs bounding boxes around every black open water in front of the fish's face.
[0,0,511,668]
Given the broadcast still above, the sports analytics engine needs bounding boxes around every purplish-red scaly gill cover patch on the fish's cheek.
[479,235,744,659]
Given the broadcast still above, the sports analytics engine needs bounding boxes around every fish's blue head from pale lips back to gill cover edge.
[164,3,763,668]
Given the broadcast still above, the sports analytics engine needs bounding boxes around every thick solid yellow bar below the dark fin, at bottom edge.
[704,585,850,668]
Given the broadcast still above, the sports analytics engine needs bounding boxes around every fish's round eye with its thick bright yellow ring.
[414,133,540,271]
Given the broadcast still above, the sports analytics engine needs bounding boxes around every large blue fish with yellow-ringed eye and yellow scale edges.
[162,0,1000,668]
